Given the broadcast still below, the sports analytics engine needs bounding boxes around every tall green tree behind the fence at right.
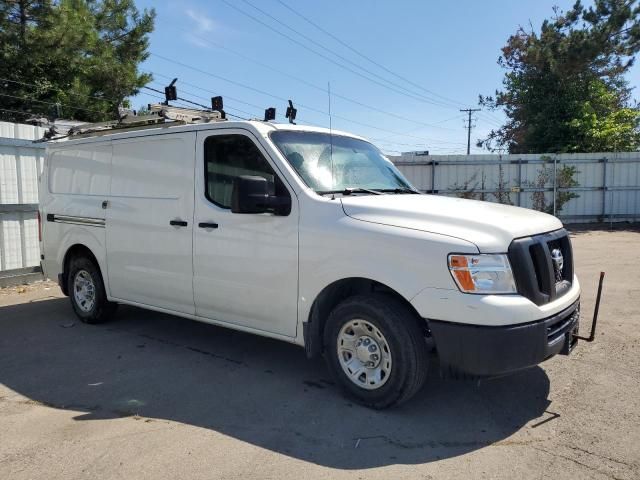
[478,0,640,153]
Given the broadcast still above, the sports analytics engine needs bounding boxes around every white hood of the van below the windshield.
[341,194,562,253]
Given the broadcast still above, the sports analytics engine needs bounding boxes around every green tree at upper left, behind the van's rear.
[0,0,155,121]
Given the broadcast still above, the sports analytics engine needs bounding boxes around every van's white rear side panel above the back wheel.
[40,143,111,284]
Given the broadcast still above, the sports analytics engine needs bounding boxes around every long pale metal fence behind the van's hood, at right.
[389,152,640,223]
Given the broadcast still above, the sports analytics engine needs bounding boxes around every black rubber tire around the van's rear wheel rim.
[67,256,118,324]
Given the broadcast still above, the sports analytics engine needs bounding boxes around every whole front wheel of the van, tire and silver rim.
[324,294,428,408]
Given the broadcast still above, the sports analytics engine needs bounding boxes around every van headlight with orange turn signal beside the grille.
[449,254,516,294]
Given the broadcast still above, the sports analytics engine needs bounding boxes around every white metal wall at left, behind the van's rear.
[0,122,45,271]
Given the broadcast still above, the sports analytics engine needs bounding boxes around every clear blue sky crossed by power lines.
[133,0,640,154]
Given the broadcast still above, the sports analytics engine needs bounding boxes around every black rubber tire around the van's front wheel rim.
[324,294,429,409]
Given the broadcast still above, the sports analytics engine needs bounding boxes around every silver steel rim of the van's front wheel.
[338,319,391,390]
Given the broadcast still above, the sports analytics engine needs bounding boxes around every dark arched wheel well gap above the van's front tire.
[303,278,428,357]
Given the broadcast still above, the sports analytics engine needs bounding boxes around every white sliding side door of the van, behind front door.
[107,132,195,314]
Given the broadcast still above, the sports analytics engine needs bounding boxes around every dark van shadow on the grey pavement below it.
[0,298,549,469]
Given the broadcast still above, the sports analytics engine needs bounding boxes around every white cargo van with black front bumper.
[40,113,580,408]
